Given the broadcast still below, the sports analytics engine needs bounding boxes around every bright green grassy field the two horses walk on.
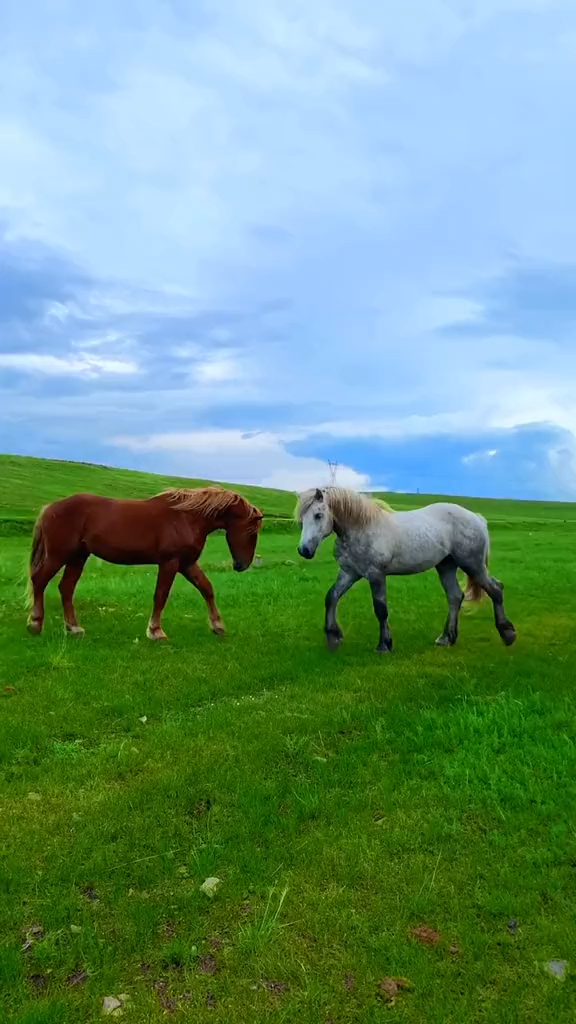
[0,457,576,1024]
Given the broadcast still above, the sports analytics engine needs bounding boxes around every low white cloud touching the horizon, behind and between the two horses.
[112,430,370,490]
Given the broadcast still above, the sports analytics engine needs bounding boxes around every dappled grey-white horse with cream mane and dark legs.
[296,486,516,653]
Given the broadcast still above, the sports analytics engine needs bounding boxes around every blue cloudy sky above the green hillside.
[0,0,576,499]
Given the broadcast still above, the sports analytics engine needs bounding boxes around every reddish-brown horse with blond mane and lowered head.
[28,486,262,640]
